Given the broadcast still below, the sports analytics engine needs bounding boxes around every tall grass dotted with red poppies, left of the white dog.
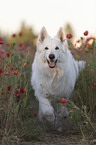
[0,44,44,144]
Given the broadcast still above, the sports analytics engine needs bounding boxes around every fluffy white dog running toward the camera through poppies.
[31,27,86,130]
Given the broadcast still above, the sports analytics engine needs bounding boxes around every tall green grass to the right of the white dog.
[68,45,96,139]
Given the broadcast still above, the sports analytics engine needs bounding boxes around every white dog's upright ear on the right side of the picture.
[56,27,68,48]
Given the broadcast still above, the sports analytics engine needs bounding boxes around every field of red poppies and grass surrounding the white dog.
[0,31,96,145]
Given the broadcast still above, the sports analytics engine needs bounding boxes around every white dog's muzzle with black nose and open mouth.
[47,54,57,68]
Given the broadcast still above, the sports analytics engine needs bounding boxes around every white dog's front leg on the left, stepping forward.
[39,97,55,123]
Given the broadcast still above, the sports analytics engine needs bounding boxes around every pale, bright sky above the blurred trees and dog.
[0,0,96,37]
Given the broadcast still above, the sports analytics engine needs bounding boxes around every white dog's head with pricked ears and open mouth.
[37,27,68,68]
